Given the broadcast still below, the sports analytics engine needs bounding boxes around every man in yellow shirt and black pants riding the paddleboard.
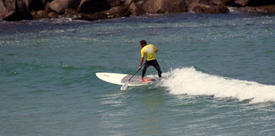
[138,40,162,82]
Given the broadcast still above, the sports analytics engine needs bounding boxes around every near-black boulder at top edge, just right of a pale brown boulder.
[78,0,110,13]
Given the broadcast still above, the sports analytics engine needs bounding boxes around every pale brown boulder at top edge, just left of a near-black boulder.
[48,0,80,14]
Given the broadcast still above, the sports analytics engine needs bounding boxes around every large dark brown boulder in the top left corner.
[2,0,32,21]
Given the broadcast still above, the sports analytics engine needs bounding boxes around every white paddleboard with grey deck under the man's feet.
[96,72,157,86]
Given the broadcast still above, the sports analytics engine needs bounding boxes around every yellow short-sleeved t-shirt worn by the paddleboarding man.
[140,44,157,61]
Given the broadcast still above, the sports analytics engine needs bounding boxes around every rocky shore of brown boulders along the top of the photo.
[0,0,275,21]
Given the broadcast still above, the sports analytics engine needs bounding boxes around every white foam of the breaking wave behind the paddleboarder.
[159,67,275,103]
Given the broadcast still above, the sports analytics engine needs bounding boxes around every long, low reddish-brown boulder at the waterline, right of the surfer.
[188,2,229,14]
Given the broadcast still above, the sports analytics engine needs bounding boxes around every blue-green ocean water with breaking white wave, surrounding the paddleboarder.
[0,13,275,136]
